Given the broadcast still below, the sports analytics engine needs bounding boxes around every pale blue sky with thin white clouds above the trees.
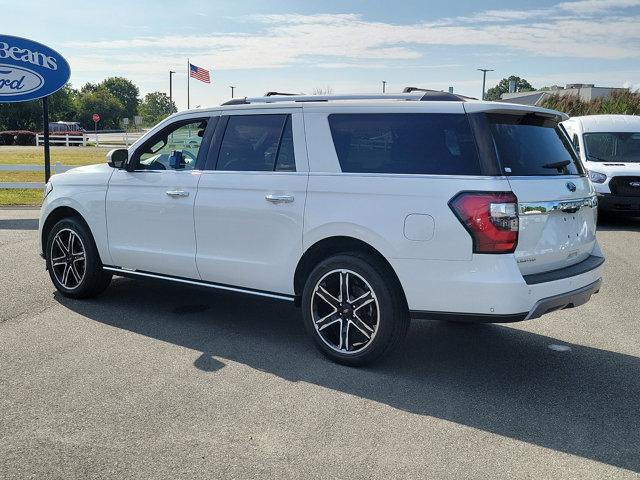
[5,0,640,108]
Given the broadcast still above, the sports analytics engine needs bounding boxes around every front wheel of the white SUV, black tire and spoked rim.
[45,217,111,298]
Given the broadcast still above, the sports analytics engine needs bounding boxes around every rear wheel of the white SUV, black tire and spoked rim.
[302,252,410,366]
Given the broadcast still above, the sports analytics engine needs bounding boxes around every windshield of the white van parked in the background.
[584,132,640,163]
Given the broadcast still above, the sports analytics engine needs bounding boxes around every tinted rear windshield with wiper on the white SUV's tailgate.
[486,113,584,176]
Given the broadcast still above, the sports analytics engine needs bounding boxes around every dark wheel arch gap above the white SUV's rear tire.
[293,235,407,306]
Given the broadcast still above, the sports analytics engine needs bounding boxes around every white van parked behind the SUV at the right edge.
[562,115,640,215]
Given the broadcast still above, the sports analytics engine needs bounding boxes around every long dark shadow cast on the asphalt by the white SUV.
[56,278,640,472]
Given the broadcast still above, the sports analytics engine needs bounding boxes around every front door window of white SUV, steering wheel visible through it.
[133,119,209,170]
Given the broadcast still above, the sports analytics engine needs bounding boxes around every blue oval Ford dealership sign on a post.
[0,35,71,103]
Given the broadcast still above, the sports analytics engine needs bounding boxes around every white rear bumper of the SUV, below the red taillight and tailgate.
[392,249,603,323]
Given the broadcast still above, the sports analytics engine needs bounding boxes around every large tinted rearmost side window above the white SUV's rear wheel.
[329,113,480,175]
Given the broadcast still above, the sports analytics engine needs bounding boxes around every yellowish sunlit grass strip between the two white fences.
[0,146,110,165]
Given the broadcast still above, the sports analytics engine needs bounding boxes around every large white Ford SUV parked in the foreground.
[40,91,604,365]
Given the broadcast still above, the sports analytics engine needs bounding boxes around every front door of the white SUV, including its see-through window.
[106,115,215,279]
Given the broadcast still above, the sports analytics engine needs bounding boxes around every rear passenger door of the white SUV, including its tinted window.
[195,108,308,294]
